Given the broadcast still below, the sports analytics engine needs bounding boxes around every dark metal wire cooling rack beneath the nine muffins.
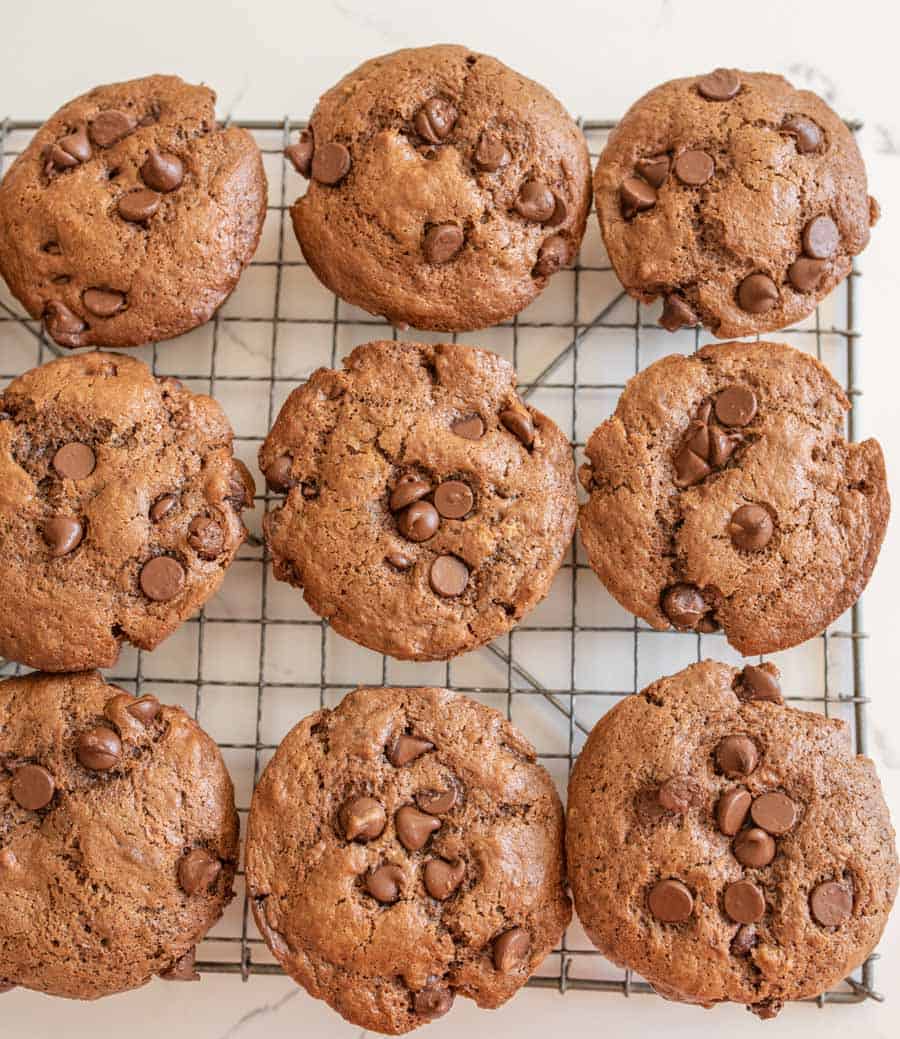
[0,116,882,1006]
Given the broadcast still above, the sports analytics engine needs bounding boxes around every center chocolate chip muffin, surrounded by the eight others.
[260,342,577,660]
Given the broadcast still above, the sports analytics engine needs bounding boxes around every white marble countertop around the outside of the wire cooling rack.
[0,0,900,1039]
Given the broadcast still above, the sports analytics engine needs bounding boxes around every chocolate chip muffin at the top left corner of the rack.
[0,76,266,347]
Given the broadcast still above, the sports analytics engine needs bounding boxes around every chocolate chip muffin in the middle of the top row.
[287,46,590,331]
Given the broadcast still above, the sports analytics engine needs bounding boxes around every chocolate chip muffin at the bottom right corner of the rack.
[566,661,897,1017]
